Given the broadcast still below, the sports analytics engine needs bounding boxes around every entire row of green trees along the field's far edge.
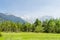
[0,19,60,33]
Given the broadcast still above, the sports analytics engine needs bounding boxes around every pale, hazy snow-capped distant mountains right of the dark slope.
[21,16,53,23]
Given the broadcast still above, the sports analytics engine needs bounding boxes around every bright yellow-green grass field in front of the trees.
[0,32,60,40]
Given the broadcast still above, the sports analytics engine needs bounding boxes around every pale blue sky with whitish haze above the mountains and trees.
[0,0,60,18]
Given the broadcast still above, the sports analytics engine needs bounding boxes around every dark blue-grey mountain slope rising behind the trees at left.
[0,13,25,23]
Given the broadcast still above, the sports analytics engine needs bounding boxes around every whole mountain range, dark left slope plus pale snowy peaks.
[0,13,53,23]
